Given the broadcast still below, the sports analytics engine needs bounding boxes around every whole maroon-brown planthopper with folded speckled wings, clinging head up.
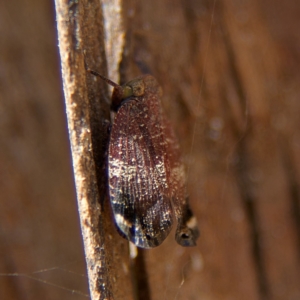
[88,70,199,248]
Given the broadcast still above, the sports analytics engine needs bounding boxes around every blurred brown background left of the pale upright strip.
[0,1,88,299]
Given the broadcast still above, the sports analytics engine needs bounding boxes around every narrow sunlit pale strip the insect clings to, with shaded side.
[56,0,132,299]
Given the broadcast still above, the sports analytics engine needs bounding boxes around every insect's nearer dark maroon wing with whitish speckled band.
[108,93,173,248]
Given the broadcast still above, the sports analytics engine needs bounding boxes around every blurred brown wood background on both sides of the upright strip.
[0,0,300,300]
